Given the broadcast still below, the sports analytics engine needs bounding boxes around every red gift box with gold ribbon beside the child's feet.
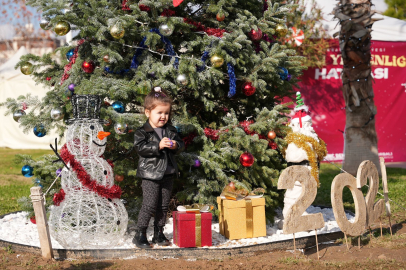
[173,211,212,247]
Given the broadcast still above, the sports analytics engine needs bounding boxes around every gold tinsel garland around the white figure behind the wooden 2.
[283,132,327,187]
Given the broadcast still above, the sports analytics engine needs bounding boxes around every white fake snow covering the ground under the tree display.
[0,206,354,249]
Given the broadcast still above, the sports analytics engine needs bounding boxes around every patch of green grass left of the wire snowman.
[0,148,53,215]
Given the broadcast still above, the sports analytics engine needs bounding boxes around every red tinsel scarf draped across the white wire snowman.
[61,144,121,199]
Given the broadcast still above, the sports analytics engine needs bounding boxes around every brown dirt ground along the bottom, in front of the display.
[0,216,406,270]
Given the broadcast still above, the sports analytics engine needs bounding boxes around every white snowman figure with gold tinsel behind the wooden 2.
[282,92,327,217]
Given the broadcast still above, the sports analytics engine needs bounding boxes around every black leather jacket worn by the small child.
[134,121,185,180]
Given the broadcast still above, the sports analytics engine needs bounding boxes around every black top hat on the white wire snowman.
[67,95,106,124]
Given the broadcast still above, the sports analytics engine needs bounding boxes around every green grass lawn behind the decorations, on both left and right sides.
[0,148,406,215]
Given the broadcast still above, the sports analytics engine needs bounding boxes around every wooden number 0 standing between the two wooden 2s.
[331,173,366,236]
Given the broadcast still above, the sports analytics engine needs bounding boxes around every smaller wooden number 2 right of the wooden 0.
[357,160,385,226]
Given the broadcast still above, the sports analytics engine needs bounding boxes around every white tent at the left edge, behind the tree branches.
[0,47,62,149]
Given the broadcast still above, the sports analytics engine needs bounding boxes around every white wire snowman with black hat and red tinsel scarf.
[49,95,128,249]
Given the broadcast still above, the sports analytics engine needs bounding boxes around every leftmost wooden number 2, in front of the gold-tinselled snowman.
[278,166,324,234]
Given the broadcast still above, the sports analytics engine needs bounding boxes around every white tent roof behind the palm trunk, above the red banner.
[306,0,406,41]
